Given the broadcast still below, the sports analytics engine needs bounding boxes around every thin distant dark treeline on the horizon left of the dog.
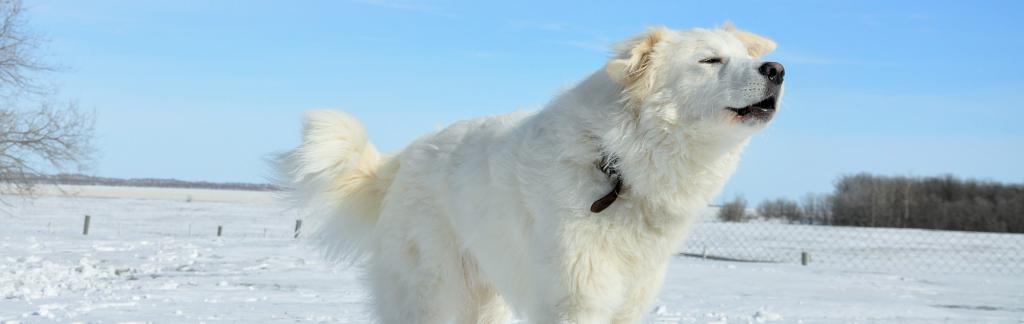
[25,173,278,191]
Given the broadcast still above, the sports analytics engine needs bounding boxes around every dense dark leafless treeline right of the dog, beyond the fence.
[719,173,1024,233]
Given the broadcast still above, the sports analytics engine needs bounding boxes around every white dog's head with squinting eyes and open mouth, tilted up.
[605,24,785,133]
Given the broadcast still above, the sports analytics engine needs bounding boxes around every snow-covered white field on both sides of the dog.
[0,188,1024,323]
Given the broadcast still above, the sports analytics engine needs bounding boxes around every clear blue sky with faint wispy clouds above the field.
[26,0,1024,201]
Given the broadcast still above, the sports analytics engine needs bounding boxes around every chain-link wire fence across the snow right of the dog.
[682,215,1024,274]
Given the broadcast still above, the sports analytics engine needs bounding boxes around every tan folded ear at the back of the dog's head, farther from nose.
[604,27,668,86]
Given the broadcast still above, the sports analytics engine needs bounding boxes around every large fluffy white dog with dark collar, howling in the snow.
[285,25,783,324]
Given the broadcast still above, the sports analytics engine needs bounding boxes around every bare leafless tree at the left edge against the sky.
[0,0,95,194]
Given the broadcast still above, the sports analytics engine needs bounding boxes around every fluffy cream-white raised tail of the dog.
[278,110,397,261]
